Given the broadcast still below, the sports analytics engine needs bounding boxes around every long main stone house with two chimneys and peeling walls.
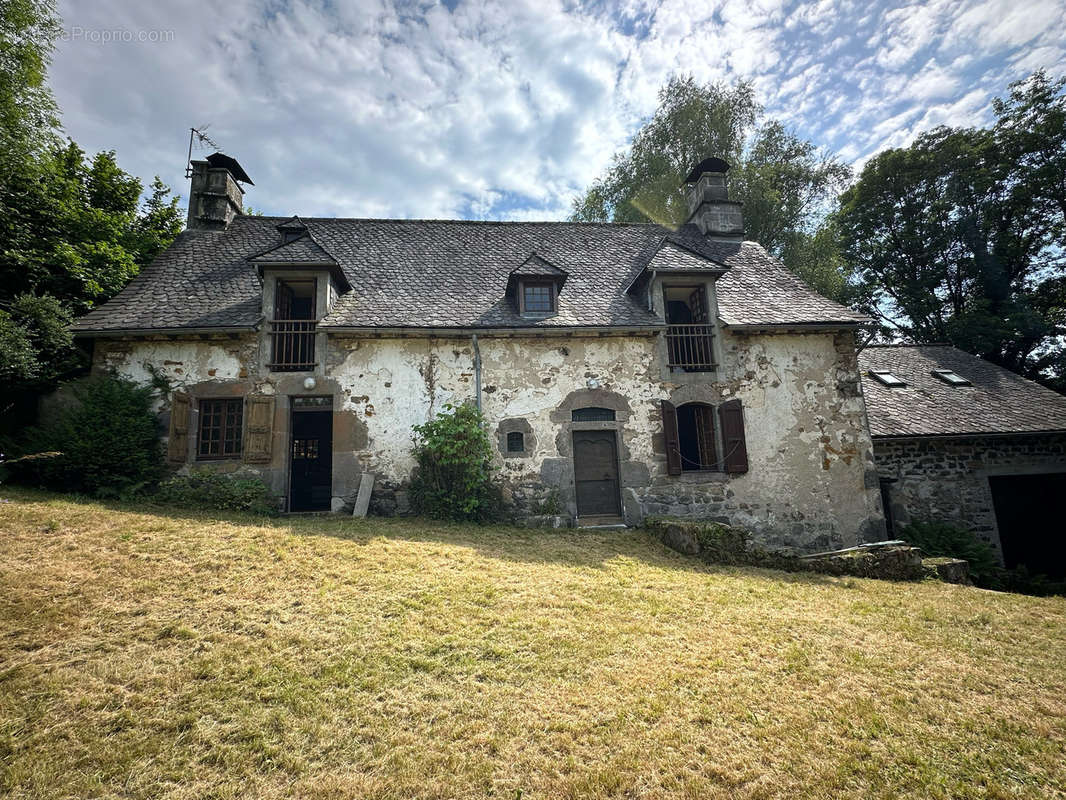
[77,154,884,548]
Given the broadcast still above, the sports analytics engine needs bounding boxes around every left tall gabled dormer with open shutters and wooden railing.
[248,217,352,372]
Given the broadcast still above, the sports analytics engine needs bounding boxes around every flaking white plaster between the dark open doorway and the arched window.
[329,337,659,483]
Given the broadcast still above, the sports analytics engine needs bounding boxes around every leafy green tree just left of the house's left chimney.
[0,142,182,409]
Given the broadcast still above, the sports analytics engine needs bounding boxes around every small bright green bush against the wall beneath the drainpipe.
[410,403,503,523]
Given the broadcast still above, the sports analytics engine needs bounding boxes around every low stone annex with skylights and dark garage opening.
[859,345,1066,577]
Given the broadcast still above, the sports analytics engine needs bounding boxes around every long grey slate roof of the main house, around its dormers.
[75,215,866,334]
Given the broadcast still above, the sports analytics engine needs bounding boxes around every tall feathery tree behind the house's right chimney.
[571,77,851,299]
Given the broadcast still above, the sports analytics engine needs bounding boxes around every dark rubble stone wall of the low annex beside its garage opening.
[874,434,1066,557]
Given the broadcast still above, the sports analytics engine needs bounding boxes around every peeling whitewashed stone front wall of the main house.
[97,332,884,549]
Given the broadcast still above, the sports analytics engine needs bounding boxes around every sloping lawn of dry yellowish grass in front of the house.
[0,490,1066,800]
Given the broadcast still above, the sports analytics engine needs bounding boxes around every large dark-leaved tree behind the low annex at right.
[837,73,1066,382]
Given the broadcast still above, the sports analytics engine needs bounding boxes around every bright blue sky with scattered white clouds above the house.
[51,0,1066,219]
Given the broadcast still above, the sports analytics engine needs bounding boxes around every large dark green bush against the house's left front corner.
[13,378,163,497]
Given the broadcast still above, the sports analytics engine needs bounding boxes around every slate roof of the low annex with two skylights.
[859,345,1066,437]
